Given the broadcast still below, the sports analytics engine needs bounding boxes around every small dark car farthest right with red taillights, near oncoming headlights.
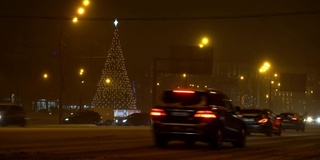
[280,112,305,131]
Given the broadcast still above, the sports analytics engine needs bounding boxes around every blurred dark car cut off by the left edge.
[0,103,27,127]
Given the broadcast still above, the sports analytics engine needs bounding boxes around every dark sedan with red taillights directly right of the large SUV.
[239,108,282,136]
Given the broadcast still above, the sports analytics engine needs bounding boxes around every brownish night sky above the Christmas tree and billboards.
[0,0,320,108]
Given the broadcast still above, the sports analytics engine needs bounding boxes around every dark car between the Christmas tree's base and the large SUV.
[116,113,151,126]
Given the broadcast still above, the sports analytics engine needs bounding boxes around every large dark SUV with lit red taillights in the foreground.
[150,90,246,149]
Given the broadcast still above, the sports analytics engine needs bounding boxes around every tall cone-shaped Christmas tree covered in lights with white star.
[91,20,136,109]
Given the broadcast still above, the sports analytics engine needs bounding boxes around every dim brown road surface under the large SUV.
[0,125,320,160]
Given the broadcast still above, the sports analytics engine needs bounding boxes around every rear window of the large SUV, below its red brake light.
[162,90,205,105]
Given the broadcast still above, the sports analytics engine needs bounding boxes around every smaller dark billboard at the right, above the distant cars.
[280,73,307,92]
